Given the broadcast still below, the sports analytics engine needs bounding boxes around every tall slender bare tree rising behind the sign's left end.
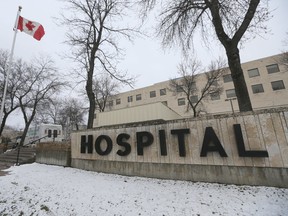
[62,0,136,128]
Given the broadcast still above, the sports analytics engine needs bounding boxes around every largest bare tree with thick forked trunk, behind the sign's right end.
[139,0,270,111]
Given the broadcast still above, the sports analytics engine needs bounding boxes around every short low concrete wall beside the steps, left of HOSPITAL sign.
[36,142,71,166]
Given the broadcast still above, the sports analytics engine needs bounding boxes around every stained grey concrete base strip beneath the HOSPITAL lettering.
[71,159,288,188]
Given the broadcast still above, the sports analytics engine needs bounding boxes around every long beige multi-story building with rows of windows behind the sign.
[95,54,288,126]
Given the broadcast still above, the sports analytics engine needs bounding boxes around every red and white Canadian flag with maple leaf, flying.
[17,16,45,41]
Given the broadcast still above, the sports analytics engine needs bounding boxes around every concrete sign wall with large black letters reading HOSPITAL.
[71,110,288,187]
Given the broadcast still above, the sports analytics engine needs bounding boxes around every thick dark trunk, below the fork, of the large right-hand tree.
[225,46,252,112]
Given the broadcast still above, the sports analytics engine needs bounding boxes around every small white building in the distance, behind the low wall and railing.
[24,124,63,145]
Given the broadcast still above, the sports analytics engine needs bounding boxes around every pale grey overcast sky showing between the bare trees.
[0,0,288,127]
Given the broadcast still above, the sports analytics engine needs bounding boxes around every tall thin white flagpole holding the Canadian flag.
[0,6,22,132]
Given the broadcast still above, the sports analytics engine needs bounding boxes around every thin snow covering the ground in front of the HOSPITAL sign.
[0,163,288,216]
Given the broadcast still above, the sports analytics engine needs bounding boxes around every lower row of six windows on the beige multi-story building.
[178,80,285,106]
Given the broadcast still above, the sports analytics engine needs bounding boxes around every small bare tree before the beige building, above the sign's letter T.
[169,59,227,117]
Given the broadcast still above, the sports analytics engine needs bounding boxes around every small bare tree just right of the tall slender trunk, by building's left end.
[93,75,120,112]
